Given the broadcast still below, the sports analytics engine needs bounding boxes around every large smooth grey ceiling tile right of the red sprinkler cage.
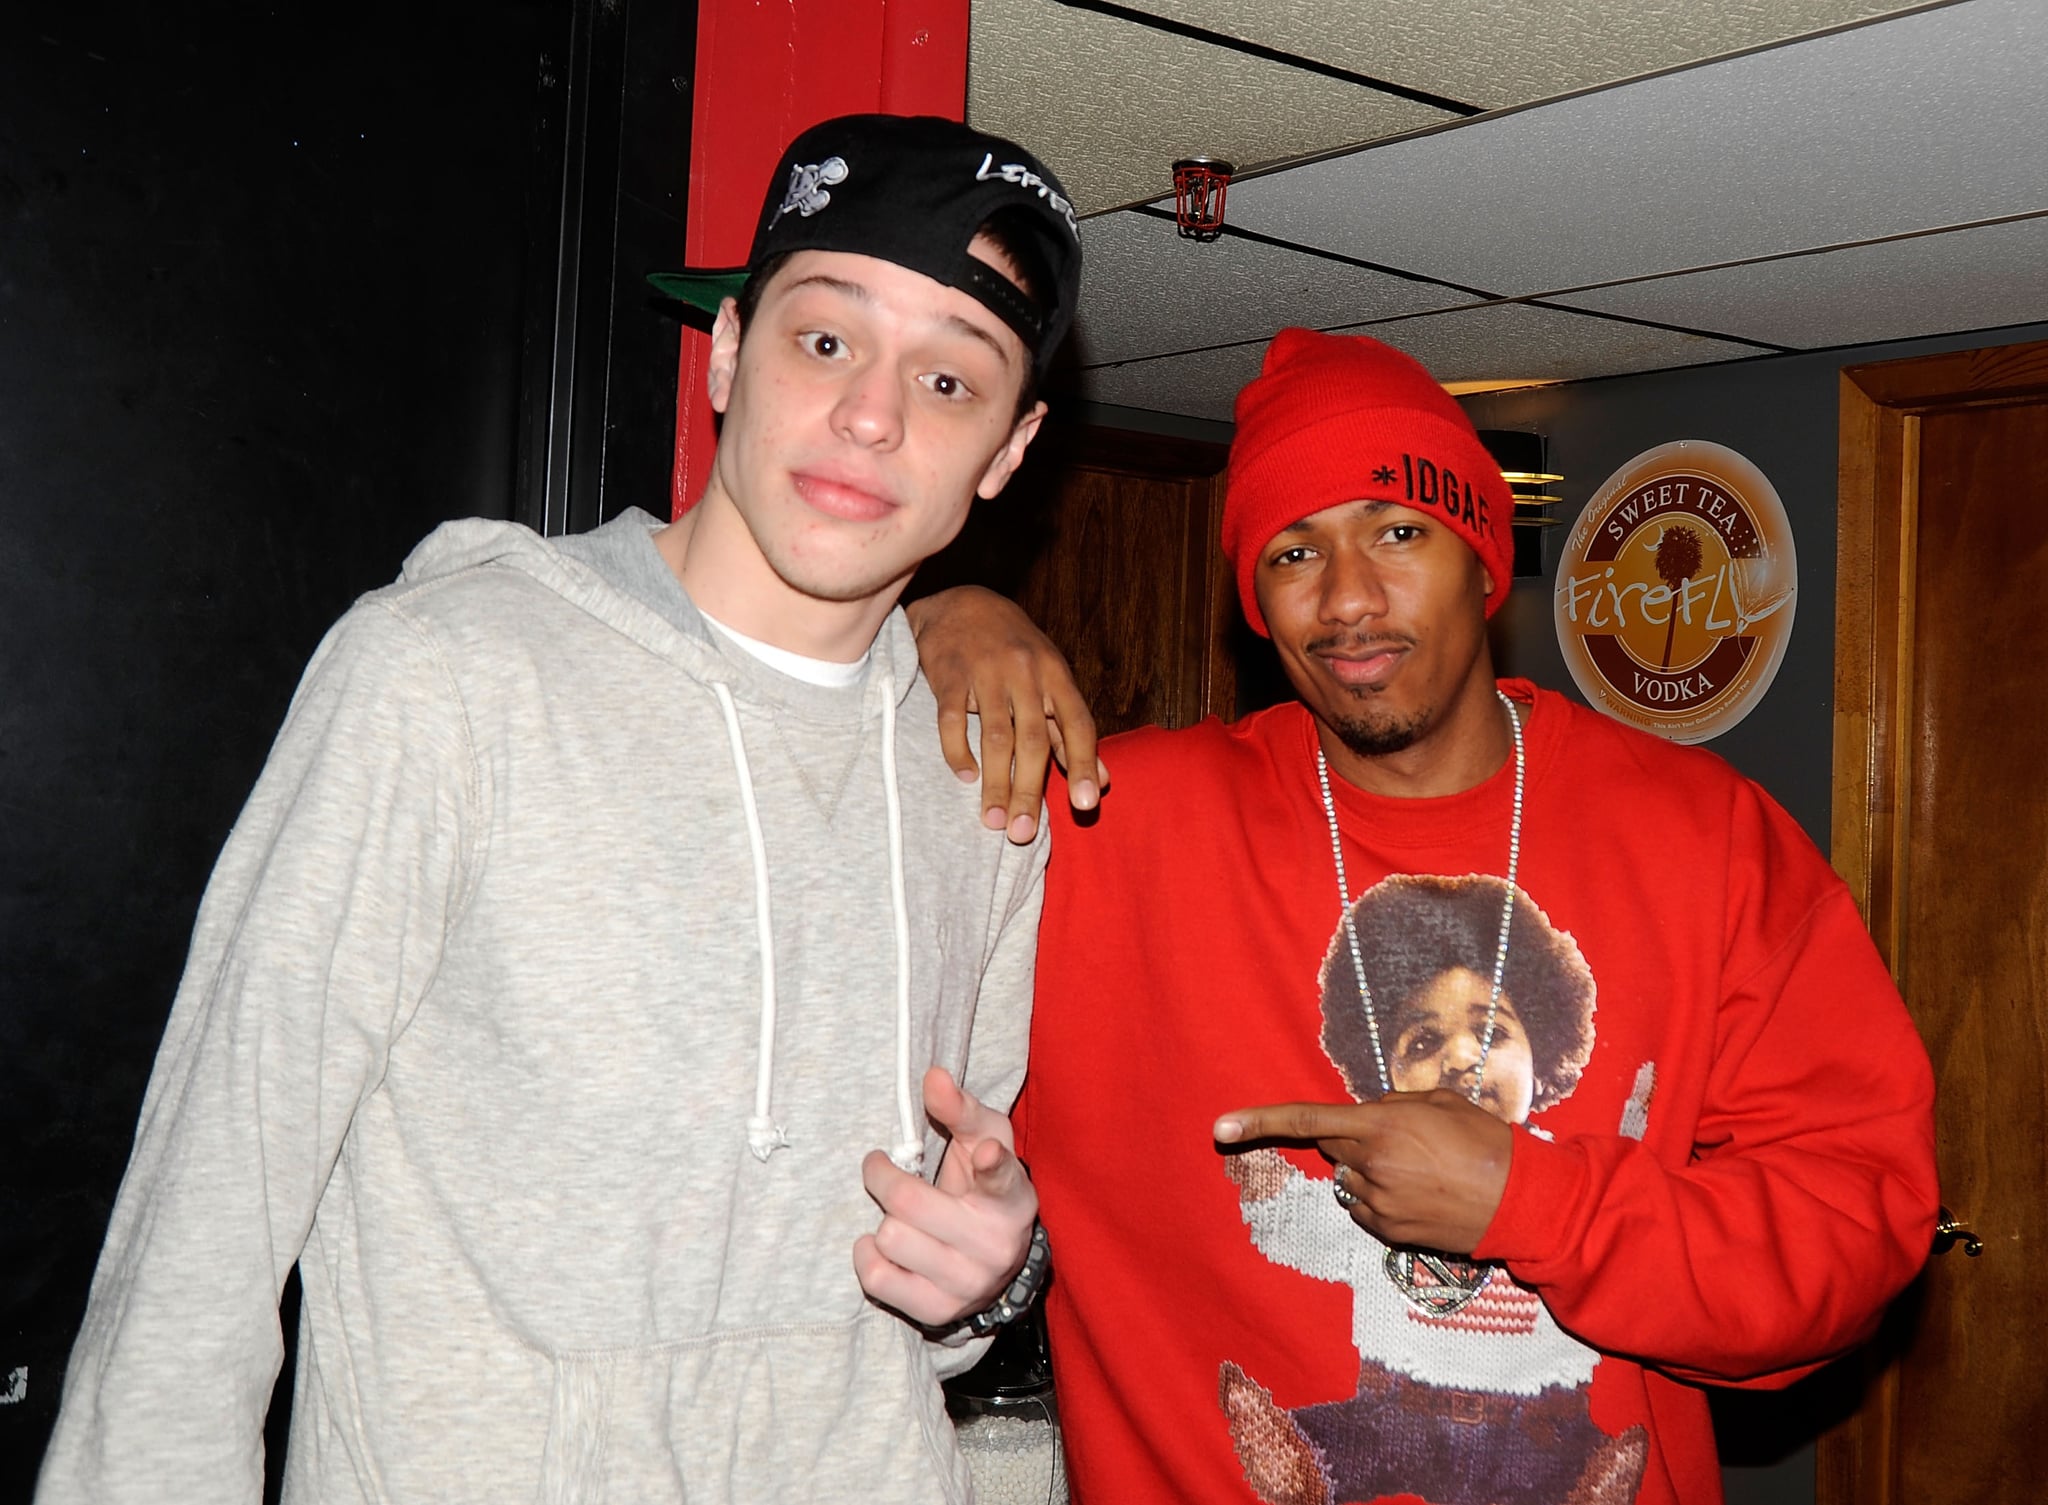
[1229,0,2048,295]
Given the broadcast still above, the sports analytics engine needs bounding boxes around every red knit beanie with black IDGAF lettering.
[1223,330,1516,637]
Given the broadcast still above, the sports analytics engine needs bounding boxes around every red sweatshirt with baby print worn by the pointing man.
[1018,682,1937,1505]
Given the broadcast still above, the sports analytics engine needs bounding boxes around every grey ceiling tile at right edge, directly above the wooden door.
[1556,217,2048,350]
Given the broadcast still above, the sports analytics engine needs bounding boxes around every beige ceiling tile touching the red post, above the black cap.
[967,0,1458,213]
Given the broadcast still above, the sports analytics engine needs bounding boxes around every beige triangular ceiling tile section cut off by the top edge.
[1139,0,1907,109]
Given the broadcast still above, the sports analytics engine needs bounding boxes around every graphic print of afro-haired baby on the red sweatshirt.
[1219,874,1655,1505]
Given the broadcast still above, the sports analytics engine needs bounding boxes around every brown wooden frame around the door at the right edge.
[1815,340,2048,1505]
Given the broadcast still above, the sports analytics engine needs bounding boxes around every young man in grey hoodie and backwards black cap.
[37,117,1079,1505]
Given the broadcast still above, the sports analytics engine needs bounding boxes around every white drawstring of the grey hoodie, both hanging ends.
[711,680,924,1175]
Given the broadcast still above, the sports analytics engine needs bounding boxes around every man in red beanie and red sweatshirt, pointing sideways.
[920,330,1935,1505]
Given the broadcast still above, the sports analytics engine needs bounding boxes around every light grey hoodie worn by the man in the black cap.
[37,514,1044,1505]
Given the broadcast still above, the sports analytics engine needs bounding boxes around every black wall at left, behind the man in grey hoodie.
[0,0,694,1501]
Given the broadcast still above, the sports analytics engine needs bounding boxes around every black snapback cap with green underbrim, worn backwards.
[647,115,1081,377]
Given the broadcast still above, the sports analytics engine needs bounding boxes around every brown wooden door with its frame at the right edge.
[1817,342,2048,1505]
